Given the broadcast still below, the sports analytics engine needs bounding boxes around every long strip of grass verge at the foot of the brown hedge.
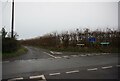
[40,47,119,53]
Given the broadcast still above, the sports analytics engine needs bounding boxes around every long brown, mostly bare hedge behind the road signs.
[21,28,120,48]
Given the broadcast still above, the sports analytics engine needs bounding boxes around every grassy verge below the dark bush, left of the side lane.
[2,47,28,59]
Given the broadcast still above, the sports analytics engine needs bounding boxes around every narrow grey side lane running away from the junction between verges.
[3,46,51,61]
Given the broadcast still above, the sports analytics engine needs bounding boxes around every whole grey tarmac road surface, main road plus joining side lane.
[3,47,120,79]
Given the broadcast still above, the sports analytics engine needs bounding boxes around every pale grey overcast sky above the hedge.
[2,2,118,39]
